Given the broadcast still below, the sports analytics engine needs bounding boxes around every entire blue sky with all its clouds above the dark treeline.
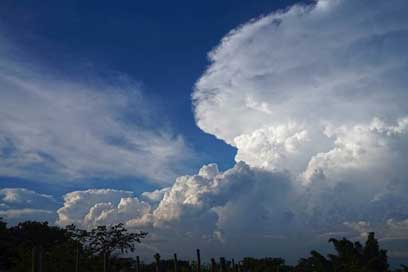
[0,0,408,262]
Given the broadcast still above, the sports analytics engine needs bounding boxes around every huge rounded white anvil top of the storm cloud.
[193,0,408,178]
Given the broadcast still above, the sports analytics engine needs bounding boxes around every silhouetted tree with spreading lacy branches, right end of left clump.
[87,223,147,272]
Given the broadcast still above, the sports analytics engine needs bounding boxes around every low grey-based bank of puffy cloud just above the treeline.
[14,158,408,261]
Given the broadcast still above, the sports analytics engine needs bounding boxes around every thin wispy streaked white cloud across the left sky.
[0,34,192,183]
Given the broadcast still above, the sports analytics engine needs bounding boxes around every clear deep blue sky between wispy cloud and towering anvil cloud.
[0,0,306,196]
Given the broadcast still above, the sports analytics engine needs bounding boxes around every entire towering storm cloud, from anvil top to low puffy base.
[2,0,408,260]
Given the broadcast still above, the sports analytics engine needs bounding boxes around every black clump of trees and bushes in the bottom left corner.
[0,220,147,272]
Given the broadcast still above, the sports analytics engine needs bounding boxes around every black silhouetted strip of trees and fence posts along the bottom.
[0,219,408,272]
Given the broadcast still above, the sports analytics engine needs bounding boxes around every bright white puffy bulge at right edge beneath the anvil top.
[303,118,408,186]
